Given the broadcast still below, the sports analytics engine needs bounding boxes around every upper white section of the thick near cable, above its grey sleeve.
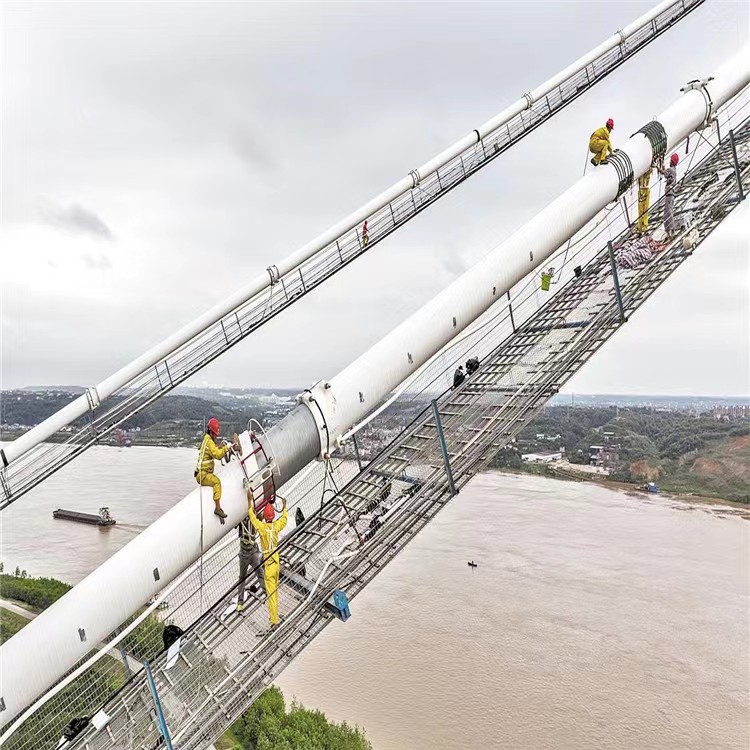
[318,47,750,449]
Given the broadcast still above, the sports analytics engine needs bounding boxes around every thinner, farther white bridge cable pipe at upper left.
[0,0,700,470]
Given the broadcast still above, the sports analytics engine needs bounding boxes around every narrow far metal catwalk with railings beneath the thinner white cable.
[0,0,704,509]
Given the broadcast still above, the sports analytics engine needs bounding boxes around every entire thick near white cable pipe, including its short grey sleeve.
[0,42,750,736]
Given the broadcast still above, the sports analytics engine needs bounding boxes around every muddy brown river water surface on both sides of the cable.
[0,448,750,750]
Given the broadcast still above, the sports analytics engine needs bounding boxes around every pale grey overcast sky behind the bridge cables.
[0,0,750,395]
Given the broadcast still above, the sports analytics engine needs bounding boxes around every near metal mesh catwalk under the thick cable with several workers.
[13,111,750,750]
